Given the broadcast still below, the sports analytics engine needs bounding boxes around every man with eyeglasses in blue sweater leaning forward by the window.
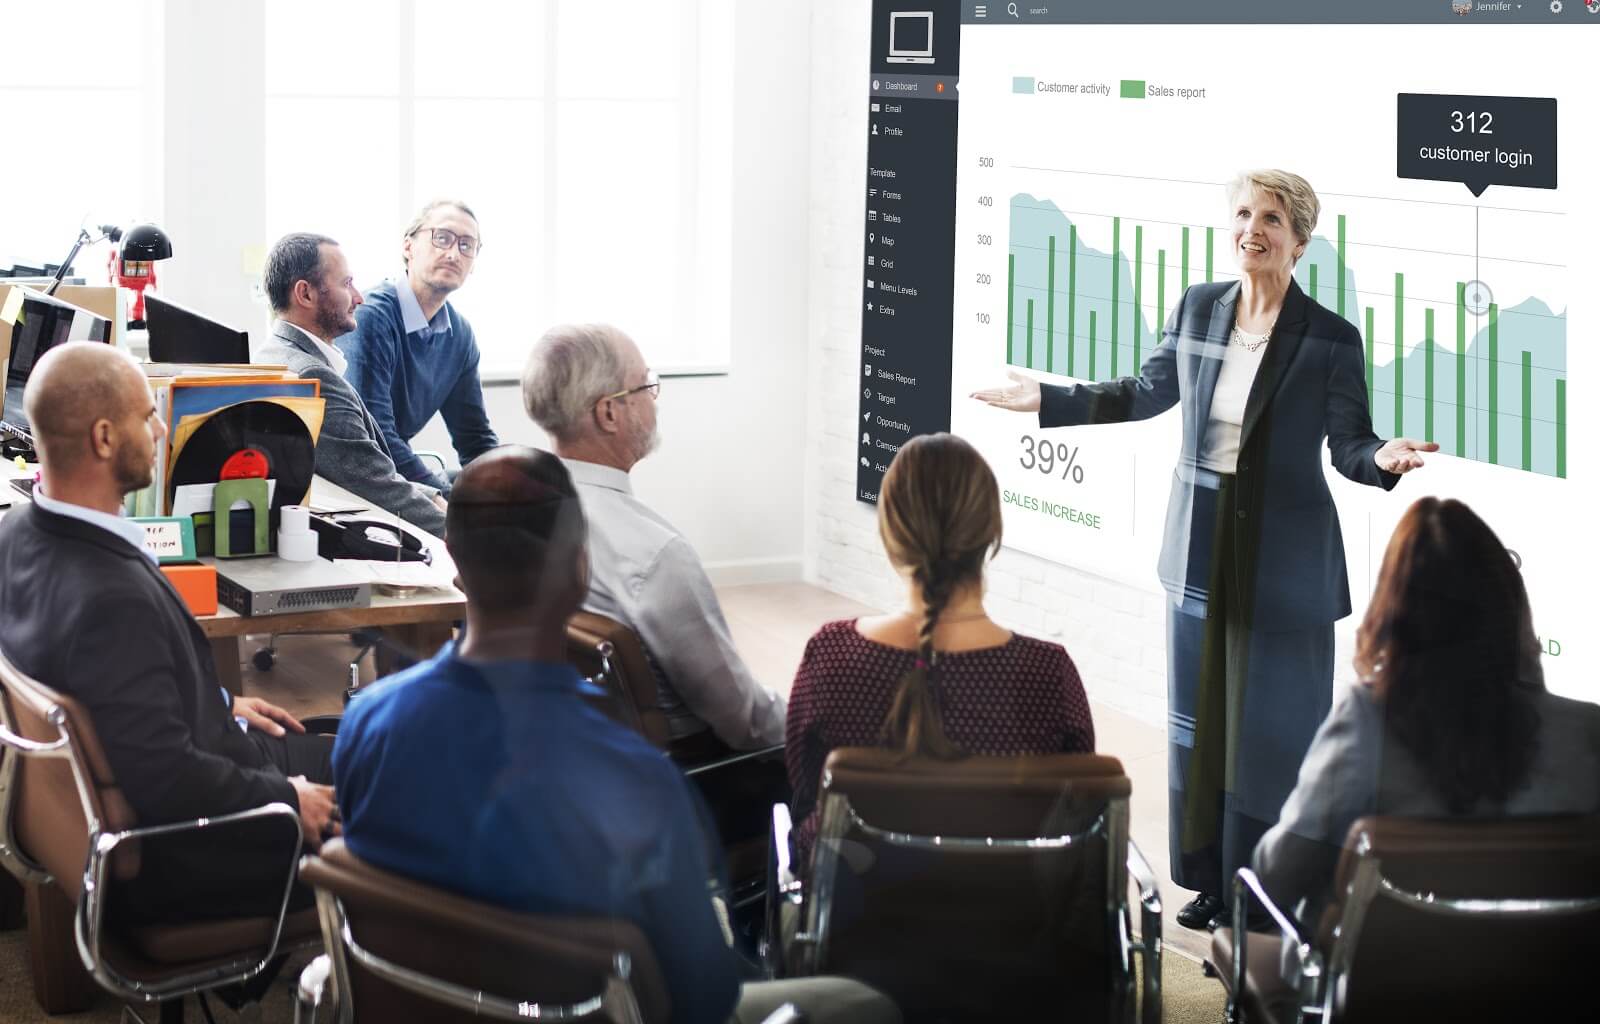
[338,200,499,494]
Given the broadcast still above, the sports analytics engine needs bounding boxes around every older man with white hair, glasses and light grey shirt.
[522,325,784,750]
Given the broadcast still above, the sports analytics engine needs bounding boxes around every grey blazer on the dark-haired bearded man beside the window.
[256,320,445,538]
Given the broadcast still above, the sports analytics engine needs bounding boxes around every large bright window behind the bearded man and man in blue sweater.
[266,0,733,376]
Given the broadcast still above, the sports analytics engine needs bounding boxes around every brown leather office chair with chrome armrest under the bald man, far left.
[0,643,317,1024]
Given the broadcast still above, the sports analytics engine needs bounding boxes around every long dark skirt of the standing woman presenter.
[1166,475,1333,896]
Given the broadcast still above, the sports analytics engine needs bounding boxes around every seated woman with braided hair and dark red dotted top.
[786,434,1094,867]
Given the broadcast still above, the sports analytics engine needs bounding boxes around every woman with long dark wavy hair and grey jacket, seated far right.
[1254,498,1600,922]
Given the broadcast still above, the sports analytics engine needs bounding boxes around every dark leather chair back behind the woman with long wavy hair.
[1323,816,1600,1022]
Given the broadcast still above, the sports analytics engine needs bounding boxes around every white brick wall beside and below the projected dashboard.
[805,0,1166,728]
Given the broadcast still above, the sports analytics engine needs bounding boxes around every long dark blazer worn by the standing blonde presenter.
[1038,282,1400,630]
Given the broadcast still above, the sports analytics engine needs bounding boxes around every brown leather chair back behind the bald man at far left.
[0,654,139,904]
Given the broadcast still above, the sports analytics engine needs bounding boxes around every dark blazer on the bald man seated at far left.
[0,504,299,826]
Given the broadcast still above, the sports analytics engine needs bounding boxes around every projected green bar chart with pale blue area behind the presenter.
[1005,192,1566,478]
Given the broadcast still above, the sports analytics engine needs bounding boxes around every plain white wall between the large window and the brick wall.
[416,3,811,582]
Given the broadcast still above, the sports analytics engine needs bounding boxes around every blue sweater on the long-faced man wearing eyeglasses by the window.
[334,280,499,494]
